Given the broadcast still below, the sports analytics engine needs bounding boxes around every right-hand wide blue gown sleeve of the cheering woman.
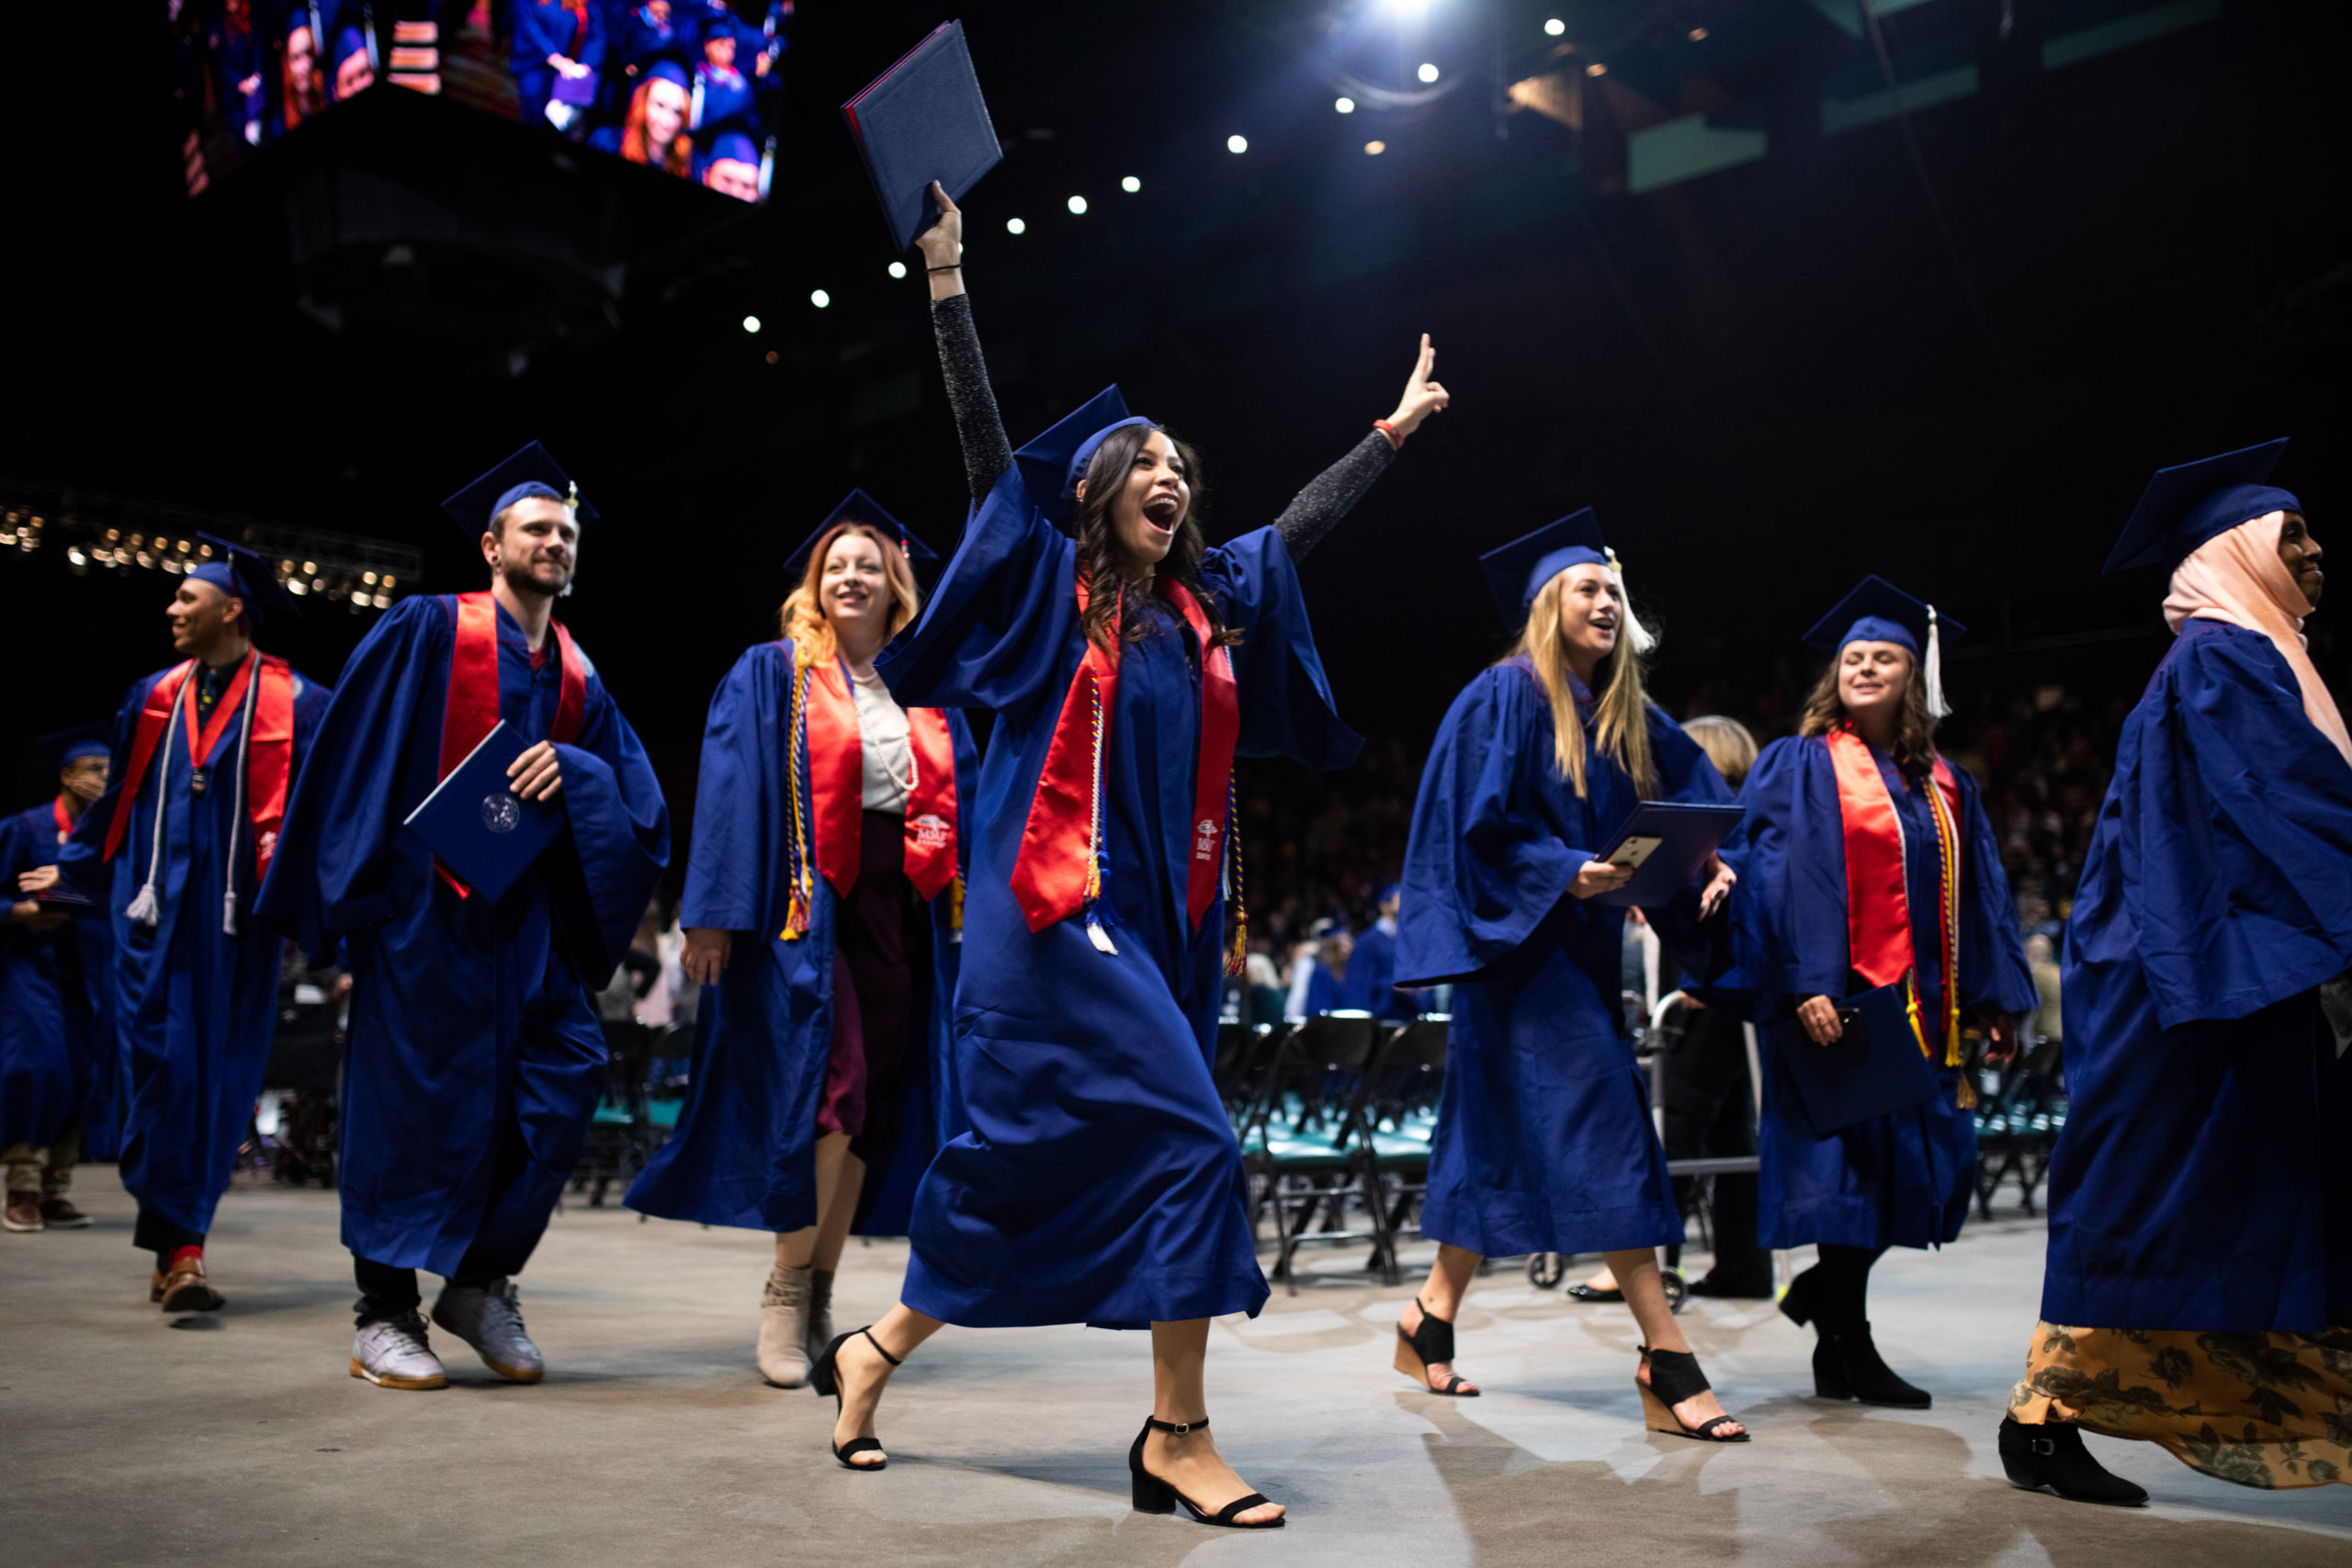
[1200,526,1387,769]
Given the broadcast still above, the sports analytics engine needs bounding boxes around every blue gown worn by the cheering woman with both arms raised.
[875,493,1362,1328]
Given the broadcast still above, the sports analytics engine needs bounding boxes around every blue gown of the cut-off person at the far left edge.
[0,802,83,1149]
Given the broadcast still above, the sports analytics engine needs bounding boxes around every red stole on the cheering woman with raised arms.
[1012,576,1242,952]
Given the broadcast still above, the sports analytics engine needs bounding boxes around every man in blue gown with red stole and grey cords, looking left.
[56,538,329,1312]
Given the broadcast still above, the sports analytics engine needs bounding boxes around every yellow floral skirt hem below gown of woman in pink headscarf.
[2008,1324,2352,1488]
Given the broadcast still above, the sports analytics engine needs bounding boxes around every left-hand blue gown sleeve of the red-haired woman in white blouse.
[677,642,790,933]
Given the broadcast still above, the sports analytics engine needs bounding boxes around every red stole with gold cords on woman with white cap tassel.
[1823,724,1969,1081]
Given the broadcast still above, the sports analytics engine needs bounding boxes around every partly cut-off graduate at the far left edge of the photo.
[0,724,122,1229]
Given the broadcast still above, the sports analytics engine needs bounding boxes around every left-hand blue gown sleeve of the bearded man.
[259,594,442,962]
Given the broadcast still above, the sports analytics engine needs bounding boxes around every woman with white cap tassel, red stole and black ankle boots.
[1724,576,2034,1408]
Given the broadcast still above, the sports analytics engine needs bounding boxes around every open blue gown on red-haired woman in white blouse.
[628,642,978,1236]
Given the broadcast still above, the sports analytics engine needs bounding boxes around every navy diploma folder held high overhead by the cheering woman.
[842,21,1004,252]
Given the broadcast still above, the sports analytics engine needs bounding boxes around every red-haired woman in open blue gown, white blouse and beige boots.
[628,491,978,1389]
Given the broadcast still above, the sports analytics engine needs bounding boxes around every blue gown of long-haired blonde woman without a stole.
[1397,659,1731,1258]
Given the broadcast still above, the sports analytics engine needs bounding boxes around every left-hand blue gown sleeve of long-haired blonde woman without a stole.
[1395,665,1597,985]
